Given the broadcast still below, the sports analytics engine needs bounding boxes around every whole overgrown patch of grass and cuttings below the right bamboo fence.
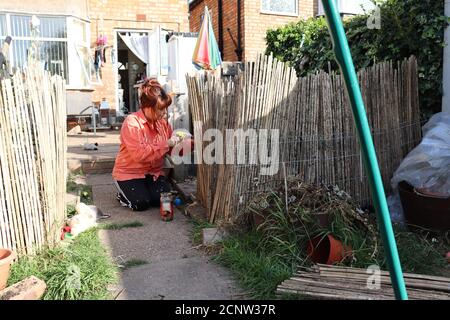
[215,181,450,299]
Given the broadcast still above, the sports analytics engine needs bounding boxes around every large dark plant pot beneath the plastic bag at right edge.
[398,181,450,231]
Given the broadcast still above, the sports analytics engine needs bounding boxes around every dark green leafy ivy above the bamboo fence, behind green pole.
[266,0,449,117]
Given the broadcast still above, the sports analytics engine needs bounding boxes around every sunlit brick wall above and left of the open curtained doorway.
[89,0,189,108]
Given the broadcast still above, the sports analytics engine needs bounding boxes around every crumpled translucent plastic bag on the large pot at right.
[391,112,450,196]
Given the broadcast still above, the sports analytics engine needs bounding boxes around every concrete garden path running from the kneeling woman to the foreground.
[87,174,243,300]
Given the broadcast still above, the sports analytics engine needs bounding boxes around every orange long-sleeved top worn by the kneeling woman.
[112,110,172,181]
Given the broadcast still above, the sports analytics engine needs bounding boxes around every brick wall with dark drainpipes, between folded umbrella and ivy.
[189,0,318,61]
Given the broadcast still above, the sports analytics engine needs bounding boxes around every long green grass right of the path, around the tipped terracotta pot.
[214,192,449,299]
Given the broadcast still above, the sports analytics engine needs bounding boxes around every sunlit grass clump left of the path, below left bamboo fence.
[8,229,118,300]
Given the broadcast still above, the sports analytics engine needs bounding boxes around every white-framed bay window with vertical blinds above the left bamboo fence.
[0,13,96,88]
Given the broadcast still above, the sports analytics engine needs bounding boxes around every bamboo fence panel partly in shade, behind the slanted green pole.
[187,55,421,222]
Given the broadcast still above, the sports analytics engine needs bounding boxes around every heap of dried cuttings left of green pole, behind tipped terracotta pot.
[247,178,380,265]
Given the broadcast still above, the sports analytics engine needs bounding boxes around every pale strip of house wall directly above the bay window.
[0,0,88,19]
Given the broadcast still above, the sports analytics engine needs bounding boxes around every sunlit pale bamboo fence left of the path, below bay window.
[0,67,67,254]
